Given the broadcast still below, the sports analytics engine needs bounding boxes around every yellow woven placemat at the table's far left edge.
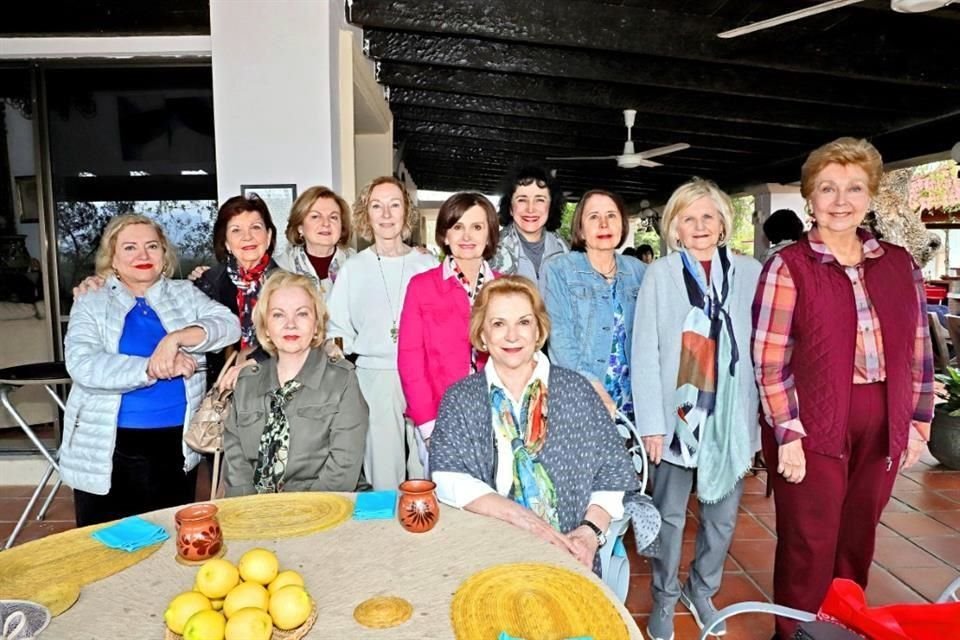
[0,524,163,616]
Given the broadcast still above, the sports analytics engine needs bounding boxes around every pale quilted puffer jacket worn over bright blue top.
[60,276,240,495]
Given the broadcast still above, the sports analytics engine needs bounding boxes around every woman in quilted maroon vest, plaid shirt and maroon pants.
[753,138,933,640]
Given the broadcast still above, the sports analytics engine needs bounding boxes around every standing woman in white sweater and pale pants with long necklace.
[327,176,437,489]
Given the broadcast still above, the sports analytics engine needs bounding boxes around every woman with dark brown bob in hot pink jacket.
[397,192,500,476]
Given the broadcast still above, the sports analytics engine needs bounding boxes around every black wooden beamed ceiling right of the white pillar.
[347,0,960,201]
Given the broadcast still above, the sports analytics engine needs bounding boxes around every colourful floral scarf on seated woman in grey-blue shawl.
[490,380,560,531]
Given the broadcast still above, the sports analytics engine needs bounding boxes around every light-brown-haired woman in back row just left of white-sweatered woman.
[277,186,357,299]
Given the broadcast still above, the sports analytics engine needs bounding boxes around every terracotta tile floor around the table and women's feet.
[0,448,960,640]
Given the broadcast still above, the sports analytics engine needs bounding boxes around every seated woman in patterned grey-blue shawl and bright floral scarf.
[430,276,638,570]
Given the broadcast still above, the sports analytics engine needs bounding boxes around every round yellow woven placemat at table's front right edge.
[450,563,630,640]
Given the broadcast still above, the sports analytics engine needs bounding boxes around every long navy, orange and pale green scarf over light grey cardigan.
[669,247,752,503]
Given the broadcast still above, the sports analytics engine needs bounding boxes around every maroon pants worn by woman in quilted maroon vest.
[762,382,900,639]
